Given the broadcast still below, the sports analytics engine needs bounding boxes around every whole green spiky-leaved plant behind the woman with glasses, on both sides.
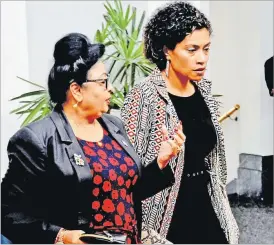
[10,0,153,127]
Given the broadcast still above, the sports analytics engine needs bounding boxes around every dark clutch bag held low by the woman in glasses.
[80,231,127,244]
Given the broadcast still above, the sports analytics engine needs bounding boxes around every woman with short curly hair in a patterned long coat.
[121,2,239,244]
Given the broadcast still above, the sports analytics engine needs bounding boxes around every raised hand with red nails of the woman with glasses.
[157,122,186,169]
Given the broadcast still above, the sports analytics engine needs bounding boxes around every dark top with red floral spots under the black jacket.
[78,129,141,244]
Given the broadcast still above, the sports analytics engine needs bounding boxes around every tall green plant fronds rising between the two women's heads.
[95,0,154,108]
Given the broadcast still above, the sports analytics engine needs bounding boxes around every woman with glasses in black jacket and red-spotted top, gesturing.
[1,33,184,244]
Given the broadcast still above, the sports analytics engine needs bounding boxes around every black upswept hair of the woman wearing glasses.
[48,33,105,105]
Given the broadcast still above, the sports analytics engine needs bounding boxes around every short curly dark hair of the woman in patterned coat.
[143,1,212,71]
